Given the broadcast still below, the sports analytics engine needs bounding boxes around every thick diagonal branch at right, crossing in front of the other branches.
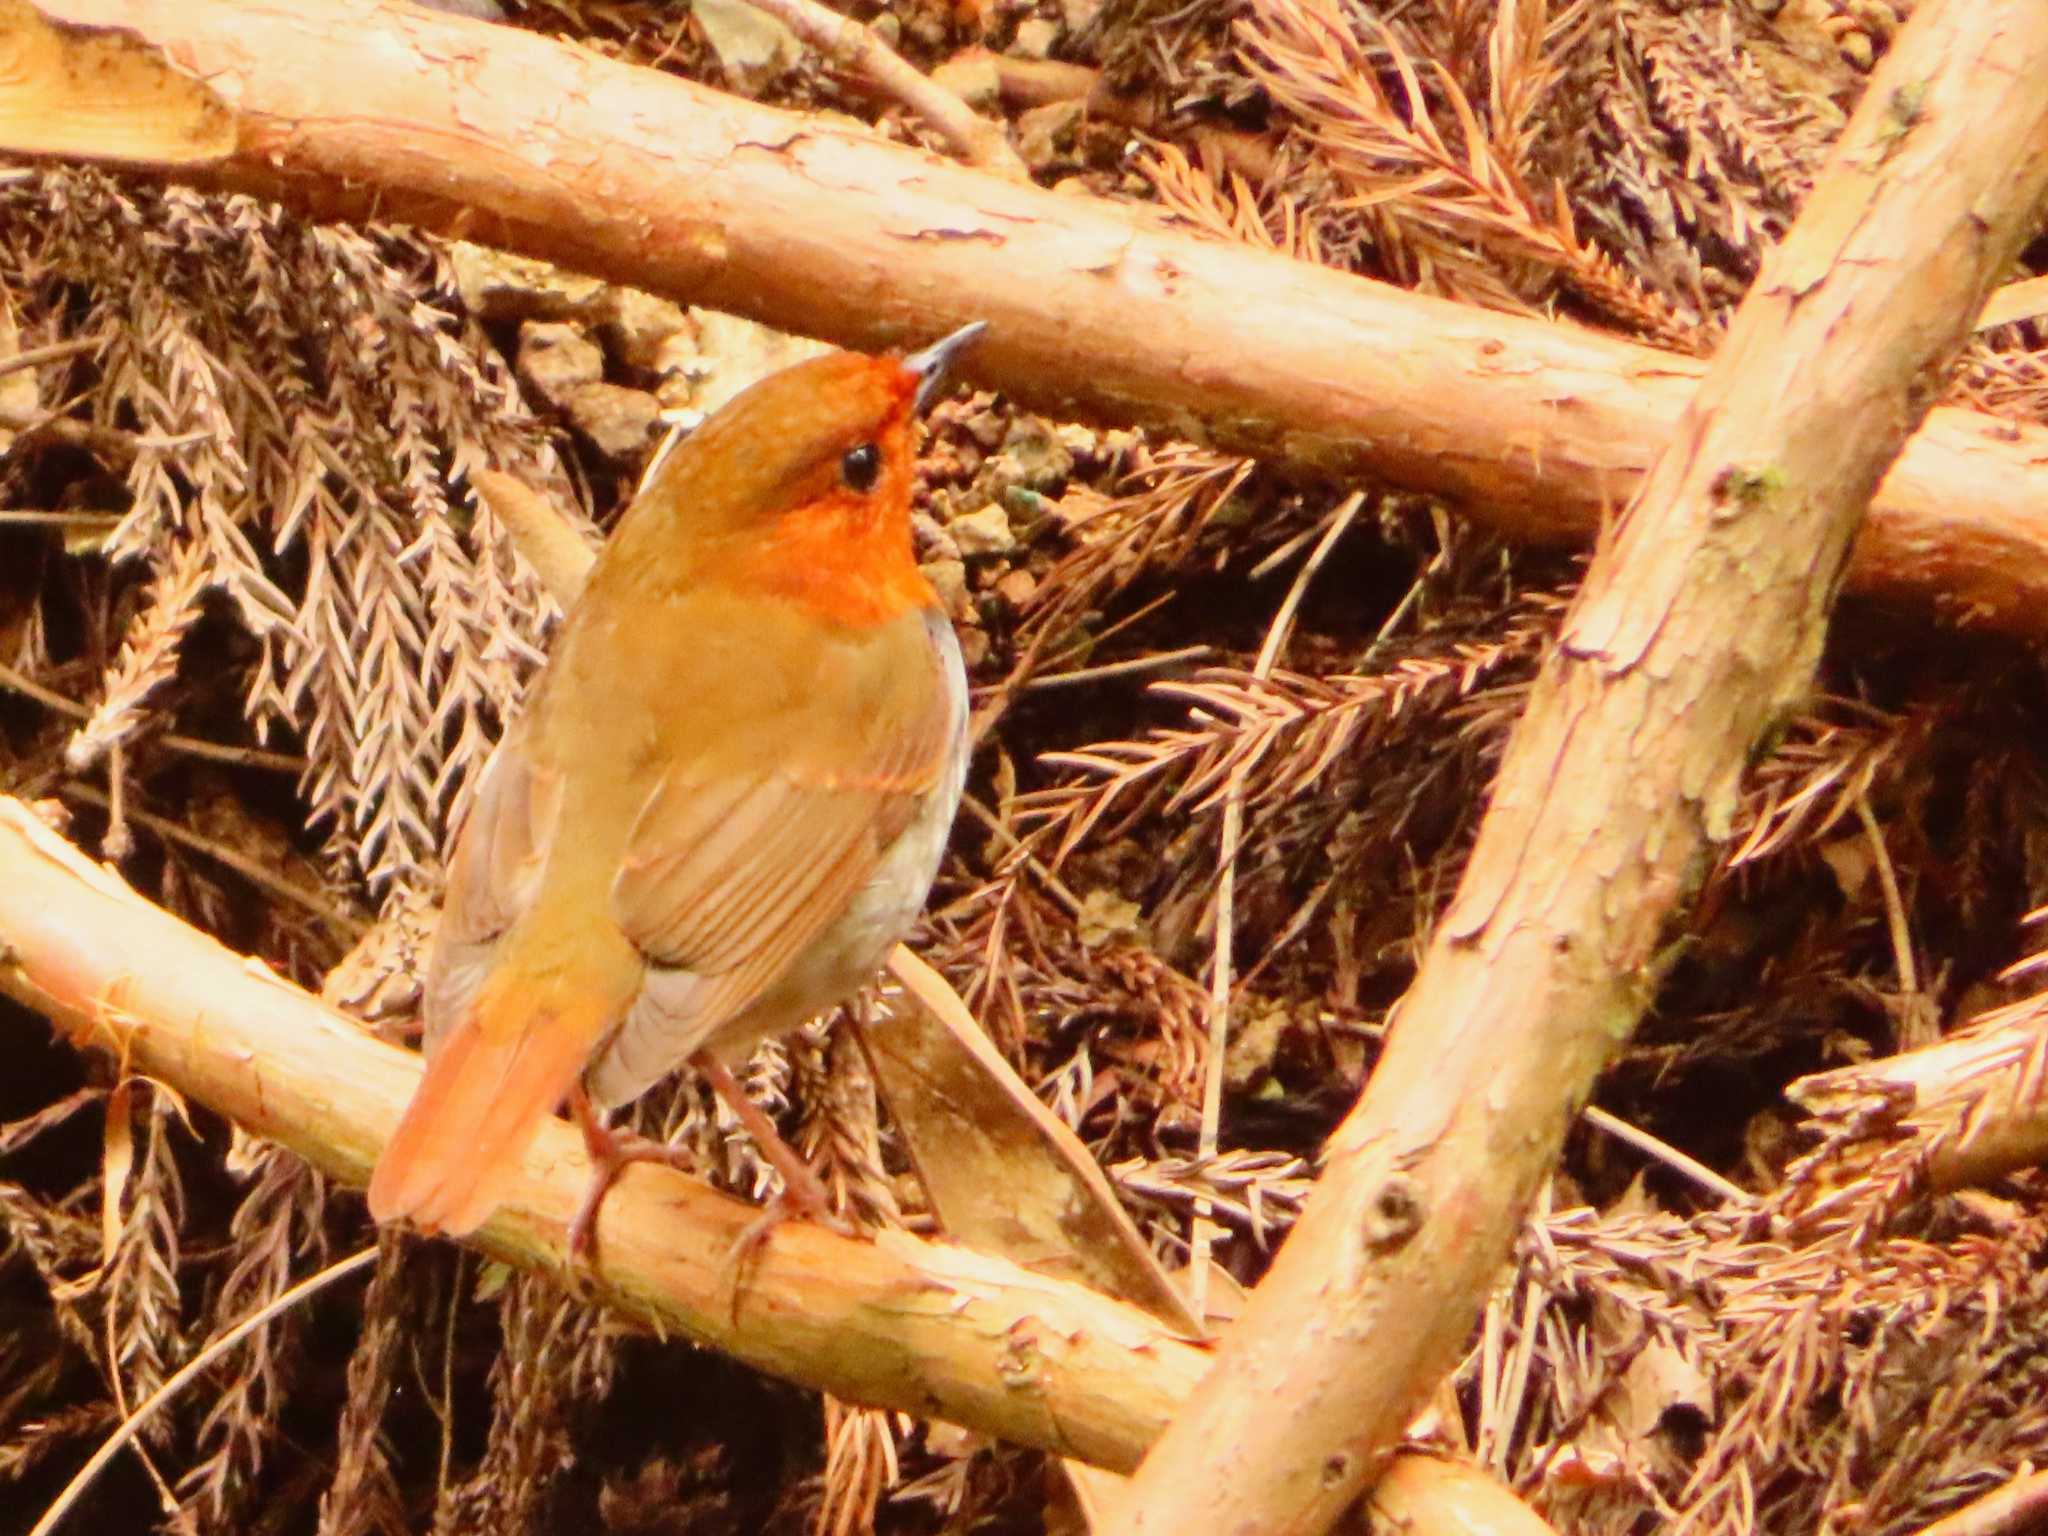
[1104,0,2048,1536]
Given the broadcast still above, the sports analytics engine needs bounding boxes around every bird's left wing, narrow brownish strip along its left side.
[420,717,561,1055]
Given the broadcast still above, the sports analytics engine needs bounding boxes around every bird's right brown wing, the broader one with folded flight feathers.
[612,625,954,1081]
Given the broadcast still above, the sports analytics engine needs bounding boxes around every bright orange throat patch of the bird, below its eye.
[733,483,938,629]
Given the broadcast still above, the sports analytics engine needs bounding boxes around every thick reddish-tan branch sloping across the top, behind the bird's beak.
[8,0,2048,635]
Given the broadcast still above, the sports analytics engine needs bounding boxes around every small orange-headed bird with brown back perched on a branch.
[371,324,983,1249]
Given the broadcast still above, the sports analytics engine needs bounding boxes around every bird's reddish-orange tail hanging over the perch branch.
[371,977,612,1237]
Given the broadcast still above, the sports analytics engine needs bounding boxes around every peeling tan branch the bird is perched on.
[0,797,1208,1468]
